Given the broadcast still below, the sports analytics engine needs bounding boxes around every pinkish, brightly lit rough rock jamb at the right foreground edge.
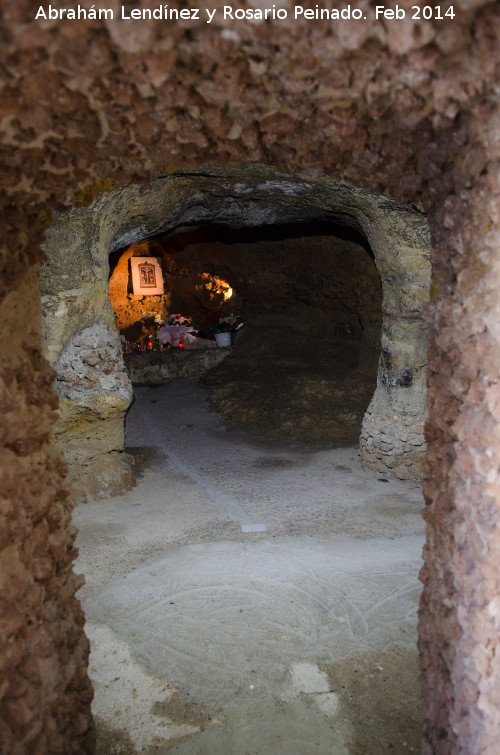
[419,140,500,755]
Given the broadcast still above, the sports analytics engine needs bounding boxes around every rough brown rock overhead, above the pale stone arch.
[1,0,496,216]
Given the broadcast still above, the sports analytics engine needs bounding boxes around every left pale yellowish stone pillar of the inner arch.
[39,211,133,501]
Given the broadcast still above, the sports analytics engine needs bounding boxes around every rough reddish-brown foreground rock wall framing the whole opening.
[0,0,500,753]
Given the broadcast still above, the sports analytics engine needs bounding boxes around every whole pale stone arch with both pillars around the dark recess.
[40,164,430,497]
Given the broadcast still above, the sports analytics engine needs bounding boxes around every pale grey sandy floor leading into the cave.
[74,381,424,755]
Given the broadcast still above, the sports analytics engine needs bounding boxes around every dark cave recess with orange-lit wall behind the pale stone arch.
[109,222,382,446]
